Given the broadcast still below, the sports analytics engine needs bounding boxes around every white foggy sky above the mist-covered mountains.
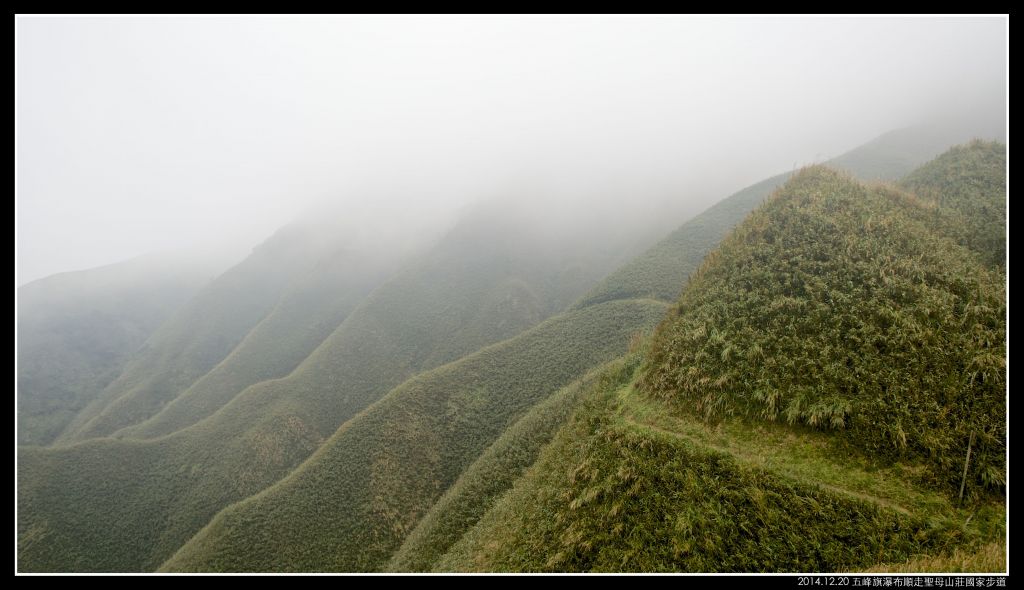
[15,16,1008,284]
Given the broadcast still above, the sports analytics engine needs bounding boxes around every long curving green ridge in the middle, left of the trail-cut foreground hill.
[164,301,665,571]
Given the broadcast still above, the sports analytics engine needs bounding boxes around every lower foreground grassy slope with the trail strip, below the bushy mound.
[433,372,1005,572]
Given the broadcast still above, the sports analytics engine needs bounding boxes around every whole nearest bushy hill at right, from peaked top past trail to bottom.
[436,143,1006,571]
